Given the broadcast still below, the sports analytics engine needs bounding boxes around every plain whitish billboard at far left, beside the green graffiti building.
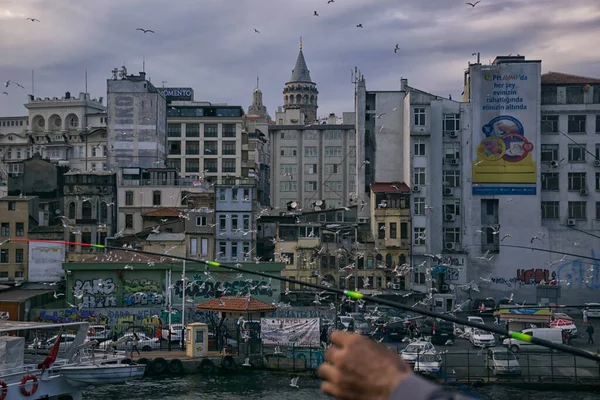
[27,242,65,282]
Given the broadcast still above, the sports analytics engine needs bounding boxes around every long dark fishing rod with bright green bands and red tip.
[10,239,600,362]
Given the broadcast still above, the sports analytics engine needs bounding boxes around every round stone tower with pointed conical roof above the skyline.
[283,38,319,122]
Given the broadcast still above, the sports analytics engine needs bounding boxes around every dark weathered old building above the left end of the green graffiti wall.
[62,171,117,261]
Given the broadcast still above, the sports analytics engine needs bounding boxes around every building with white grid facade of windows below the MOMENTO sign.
[167,101,248,187]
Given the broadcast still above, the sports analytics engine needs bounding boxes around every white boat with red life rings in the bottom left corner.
[0,321,89,400]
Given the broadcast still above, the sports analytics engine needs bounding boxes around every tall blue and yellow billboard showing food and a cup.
[471,63,540,195]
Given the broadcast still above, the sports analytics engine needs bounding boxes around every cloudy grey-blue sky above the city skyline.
[0,0,600,117]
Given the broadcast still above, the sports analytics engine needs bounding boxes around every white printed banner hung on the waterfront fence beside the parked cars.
[260,318,320,347]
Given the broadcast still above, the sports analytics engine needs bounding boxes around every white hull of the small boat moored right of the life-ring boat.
[60,364,146,387]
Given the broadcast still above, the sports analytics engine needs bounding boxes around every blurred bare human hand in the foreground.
[318,331,412,400]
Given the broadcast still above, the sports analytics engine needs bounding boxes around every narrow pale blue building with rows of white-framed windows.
[215,179,257,262]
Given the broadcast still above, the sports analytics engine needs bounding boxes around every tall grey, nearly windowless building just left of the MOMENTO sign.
[106,67,167,170]
